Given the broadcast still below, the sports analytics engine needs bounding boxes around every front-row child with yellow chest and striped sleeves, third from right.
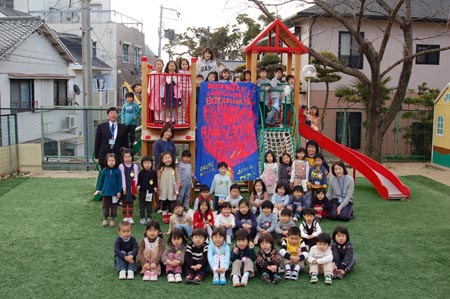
[280,226,308,280]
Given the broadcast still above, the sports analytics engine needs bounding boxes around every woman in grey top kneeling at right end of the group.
[327,161,355,221]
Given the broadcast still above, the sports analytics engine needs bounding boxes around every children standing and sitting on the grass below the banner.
[106,148,355,286]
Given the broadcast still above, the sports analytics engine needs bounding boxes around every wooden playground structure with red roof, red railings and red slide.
[141,19,410,199]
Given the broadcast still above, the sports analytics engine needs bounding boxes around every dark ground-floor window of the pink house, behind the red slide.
[336,112,362,149]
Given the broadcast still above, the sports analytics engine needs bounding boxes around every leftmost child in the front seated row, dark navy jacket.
[114,221,138,279]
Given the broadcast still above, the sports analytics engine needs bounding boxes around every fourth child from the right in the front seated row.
[256,233,281,284]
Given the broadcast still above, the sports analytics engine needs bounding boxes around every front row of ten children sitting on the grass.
[114,220,355,287]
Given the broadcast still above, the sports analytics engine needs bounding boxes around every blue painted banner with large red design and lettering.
[195,82,259,186]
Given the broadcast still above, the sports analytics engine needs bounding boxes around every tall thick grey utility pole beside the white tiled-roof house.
[81,0,94,170]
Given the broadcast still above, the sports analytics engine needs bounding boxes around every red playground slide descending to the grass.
[299,120,410,200]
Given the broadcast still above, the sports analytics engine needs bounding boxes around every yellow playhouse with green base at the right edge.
[431,83,450,167]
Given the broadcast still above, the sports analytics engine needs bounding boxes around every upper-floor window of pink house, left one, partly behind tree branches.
[339,32,364,69]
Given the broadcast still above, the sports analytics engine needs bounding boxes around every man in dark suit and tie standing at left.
[94,107,129,169]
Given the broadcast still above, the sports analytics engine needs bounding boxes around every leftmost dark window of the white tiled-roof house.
[10,79,34,113]
